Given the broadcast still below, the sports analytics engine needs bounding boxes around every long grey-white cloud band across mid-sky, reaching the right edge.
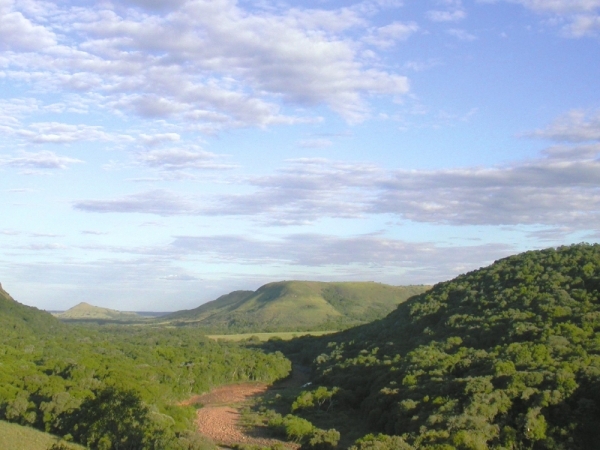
[76,145,600,230]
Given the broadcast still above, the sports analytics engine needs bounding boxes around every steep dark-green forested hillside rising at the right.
[270,244,600,450]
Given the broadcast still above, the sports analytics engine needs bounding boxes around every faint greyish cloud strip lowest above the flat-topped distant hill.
[168,234,513,283]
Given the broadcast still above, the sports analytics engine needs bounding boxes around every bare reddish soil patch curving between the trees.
[185,383,297,448]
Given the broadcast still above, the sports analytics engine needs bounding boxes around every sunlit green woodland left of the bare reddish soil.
[0,295,290,449]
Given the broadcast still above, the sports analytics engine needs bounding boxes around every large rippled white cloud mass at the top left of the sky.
[0,0,418,127]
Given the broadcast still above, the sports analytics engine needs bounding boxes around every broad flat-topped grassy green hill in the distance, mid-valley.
[159,281,428,332]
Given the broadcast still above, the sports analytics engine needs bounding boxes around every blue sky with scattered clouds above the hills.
[0,0,600,311]
